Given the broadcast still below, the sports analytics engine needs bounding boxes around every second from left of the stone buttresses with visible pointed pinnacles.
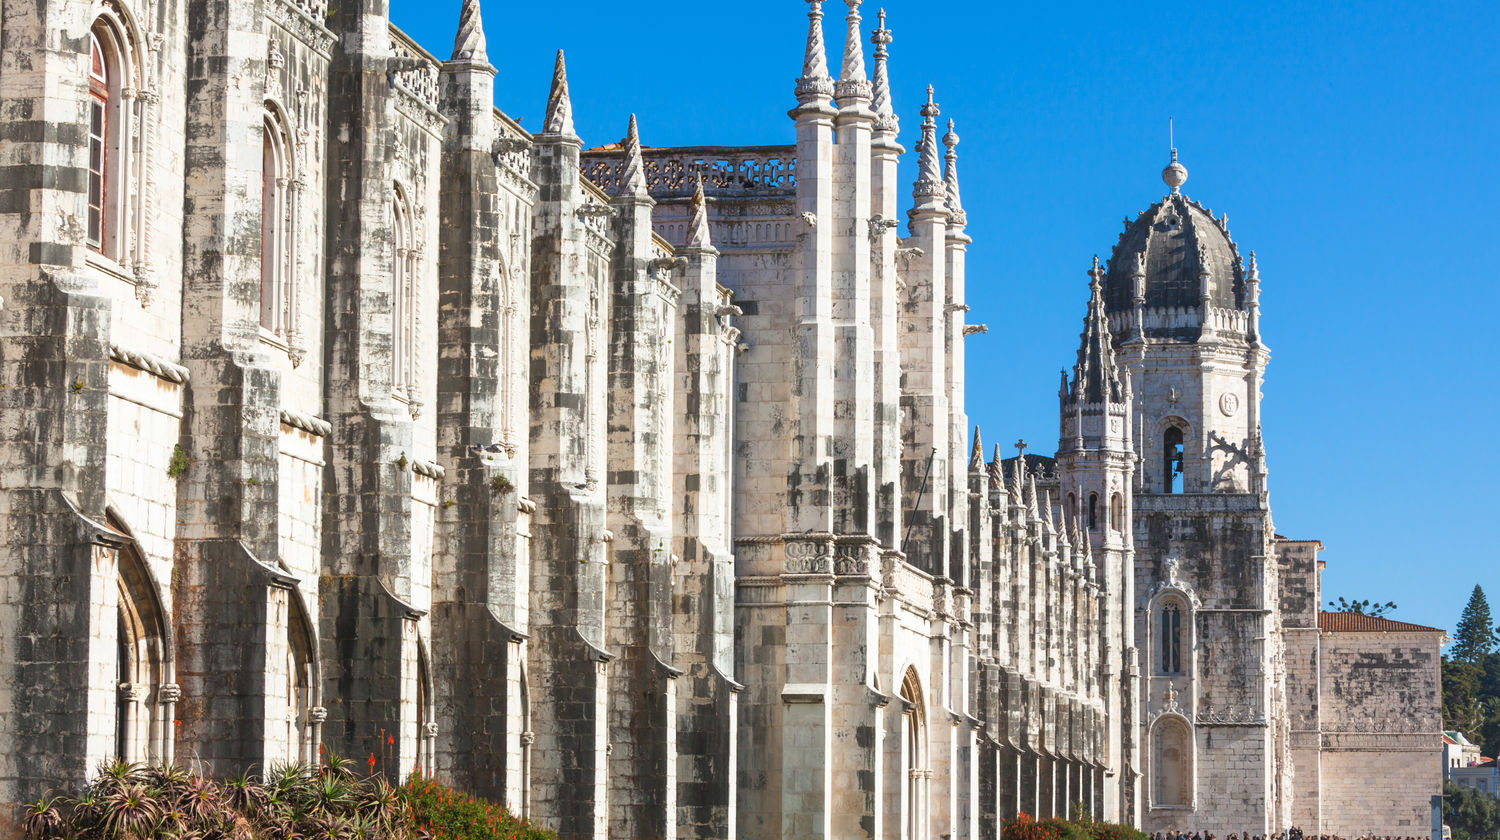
[528,53,615,840]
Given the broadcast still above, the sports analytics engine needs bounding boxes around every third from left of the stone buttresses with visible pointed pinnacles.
[603,117,683,840]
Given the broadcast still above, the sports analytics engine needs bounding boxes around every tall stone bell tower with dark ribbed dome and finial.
[1101,149,1290,834]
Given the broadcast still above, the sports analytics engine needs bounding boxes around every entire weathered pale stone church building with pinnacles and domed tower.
[0,0,1437,840]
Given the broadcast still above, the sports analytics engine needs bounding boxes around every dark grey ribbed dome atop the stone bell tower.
[1104,194,1245,319]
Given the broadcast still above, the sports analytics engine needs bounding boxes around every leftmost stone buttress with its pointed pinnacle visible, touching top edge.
[432,0,534,813]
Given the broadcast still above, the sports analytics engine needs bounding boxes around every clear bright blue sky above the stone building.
[392,0,1500,629]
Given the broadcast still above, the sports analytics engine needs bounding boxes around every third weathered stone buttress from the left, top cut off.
[321,0,441,777]
